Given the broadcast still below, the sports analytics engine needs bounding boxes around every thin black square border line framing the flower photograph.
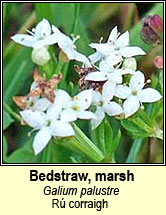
[0,1,166,166]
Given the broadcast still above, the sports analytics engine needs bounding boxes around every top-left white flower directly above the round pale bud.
[11,19,57,49]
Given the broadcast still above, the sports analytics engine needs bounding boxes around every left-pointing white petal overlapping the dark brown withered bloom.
[85,72,108,81]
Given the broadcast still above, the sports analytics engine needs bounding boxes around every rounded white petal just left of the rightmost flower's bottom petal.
[103,102,123,116]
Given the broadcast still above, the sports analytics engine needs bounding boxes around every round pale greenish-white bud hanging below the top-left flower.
[31,47,51,66]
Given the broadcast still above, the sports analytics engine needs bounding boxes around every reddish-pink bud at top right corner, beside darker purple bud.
[149,14,163,34]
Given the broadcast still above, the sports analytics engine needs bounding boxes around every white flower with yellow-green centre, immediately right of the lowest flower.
[61,89,95,121]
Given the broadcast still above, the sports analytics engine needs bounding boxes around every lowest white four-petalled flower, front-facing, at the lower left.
[20,90,74,155]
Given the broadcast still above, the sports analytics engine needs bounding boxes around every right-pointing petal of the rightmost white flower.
[138,88,162,102]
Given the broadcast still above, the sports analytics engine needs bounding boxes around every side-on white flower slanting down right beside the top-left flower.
[52,25,91,67]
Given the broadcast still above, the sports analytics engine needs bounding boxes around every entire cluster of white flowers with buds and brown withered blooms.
[12,19,161,154]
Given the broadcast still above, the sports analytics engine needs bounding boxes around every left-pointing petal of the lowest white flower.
[20,110,46,129]
